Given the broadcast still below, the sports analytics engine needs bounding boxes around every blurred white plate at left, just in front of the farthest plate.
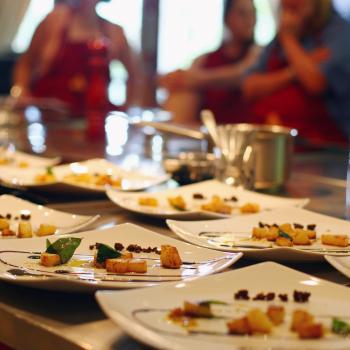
[0,159,169,193]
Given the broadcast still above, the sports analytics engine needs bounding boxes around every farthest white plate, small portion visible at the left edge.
[0,147,60,172]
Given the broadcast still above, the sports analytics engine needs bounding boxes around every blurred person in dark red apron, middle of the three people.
[159,0,260,123]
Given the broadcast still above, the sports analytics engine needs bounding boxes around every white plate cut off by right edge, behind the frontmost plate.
[167,208,350,261]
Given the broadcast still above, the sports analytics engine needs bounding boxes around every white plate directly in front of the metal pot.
[107,180,309,220]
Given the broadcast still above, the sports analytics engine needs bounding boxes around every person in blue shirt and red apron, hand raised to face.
[243,0,350,145]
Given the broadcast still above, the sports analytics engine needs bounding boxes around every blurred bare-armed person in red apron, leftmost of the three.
[11,0,141,116]
